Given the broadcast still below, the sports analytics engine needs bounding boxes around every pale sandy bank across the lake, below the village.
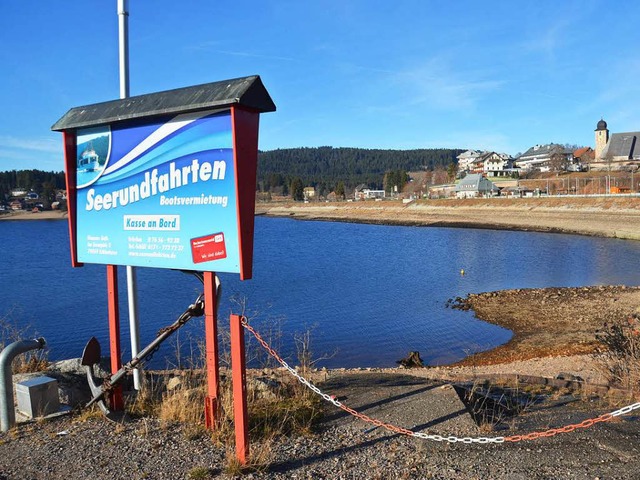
[256,196,640,240]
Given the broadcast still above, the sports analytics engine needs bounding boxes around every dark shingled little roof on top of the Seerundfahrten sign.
[51,75,276,131]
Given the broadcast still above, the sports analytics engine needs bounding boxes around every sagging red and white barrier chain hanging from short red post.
[242,318,640,444]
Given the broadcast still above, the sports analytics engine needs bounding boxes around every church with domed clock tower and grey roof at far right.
[591,119,640,170]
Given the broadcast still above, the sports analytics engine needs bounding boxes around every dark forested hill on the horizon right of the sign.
[258,147,463,191]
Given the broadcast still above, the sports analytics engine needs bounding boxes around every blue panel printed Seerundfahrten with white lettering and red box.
[76,110,241,273]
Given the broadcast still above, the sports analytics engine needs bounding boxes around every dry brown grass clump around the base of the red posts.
[123,364,321,468]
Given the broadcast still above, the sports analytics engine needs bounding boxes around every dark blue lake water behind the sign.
[0,217,640,367]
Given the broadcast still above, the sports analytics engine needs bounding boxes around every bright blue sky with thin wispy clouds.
[0,0,640,170]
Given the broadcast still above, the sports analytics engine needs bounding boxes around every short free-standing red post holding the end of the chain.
[231,315,249,465]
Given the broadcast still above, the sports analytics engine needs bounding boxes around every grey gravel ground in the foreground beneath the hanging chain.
[0,360,640,480]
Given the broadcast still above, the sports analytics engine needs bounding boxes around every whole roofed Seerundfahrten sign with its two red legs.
[52,76,276,446]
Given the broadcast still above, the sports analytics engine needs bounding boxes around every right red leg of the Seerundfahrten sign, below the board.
[204,272,220,430]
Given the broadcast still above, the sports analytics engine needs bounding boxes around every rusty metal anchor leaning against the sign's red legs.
[80,272,220,419]
